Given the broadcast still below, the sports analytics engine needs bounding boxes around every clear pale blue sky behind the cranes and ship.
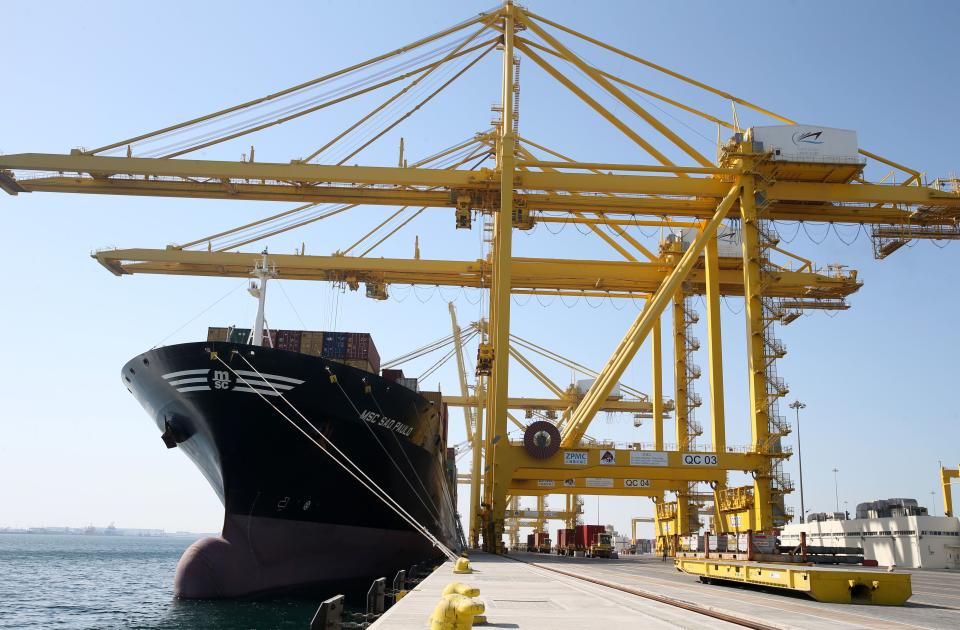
[0,0,960,544]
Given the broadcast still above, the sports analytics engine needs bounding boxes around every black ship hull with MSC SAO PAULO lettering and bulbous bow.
[123,342,458,598]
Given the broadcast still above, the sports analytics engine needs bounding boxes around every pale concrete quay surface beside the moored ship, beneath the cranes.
[371,552,960,630]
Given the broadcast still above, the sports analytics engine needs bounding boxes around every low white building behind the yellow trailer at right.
[780,515,960,569]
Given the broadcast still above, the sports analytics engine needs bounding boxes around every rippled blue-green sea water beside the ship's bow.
[0,533,349,630]
